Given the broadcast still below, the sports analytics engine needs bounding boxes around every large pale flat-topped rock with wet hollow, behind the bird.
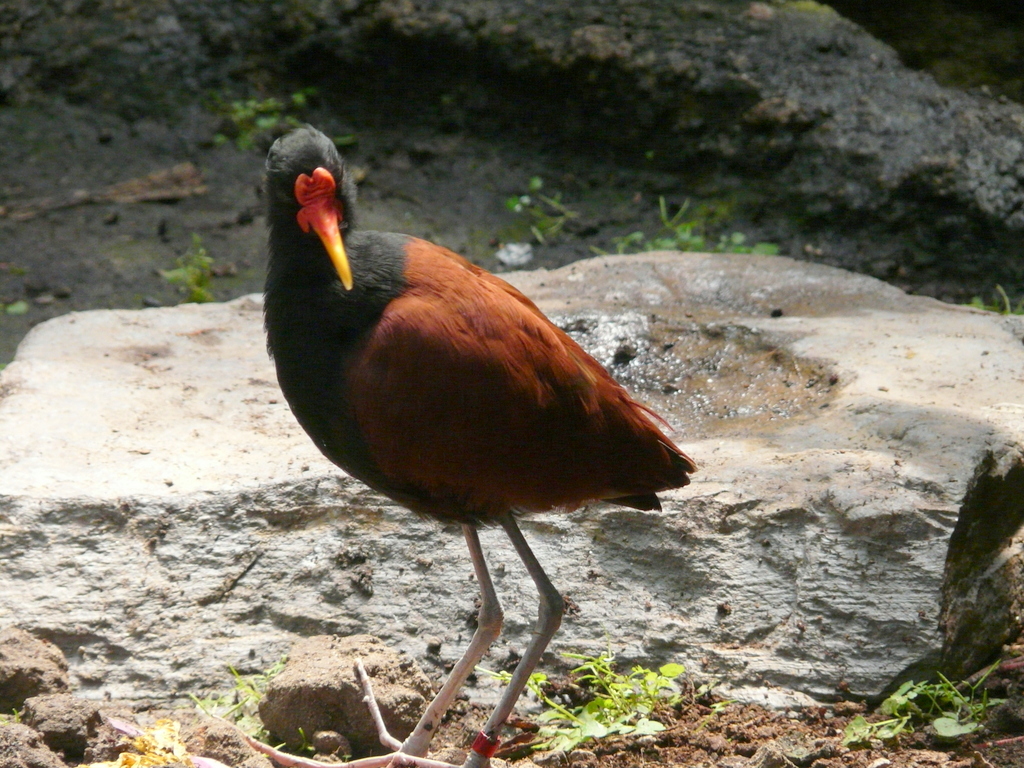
[0,254,1024,698]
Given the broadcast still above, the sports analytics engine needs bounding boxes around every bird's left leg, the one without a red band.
[401,525,503,756]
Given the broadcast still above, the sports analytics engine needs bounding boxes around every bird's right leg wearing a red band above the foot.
[463,512,565,768]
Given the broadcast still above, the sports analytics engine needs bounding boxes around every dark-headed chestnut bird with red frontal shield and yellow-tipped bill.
[263,126,696,768]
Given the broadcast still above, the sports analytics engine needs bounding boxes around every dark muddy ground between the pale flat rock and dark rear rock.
[0,99,704,365]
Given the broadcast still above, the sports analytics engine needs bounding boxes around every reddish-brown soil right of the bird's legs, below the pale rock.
[305,669,1024,768]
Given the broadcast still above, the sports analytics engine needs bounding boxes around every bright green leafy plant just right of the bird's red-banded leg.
[481,653,686,752]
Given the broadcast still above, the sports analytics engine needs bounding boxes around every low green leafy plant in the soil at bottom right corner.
[843,665,1002,746]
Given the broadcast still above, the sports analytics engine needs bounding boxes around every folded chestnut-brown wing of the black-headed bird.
[349,240,694,519]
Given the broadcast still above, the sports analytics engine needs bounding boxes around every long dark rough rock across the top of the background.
[0,0,1024,298]
